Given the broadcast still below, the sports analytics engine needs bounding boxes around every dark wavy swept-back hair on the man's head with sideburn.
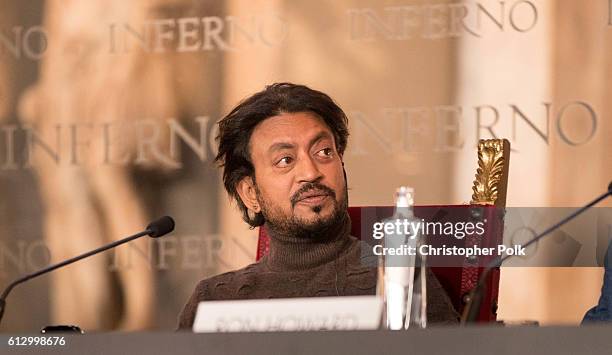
[215,83,349,227]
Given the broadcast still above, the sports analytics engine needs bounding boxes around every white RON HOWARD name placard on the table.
[193,296,383,333]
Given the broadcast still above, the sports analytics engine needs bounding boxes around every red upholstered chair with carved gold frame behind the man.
[257,139,510,322]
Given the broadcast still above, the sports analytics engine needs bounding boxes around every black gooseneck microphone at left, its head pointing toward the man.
[0,216,174,322]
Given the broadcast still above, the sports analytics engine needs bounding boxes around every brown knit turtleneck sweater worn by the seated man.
[179,217,458,329]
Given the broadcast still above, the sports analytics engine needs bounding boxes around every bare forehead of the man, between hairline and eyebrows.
[250,112,333,149]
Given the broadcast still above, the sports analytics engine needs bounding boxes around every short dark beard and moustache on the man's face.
[255,182,349,241]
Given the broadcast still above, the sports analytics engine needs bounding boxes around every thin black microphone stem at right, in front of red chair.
[461,182,612,325]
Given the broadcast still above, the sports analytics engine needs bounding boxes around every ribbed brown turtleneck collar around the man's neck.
[263,214,351,271]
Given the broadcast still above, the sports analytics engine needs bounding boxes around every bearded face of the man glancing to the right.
[247,112,347,236]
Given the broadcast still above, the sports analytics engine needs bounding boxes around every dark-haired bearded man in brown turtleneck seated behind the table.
[179,83,457,328]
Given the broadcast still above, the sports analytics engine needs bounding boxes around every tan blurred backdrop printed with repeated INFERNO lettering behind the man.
[0,0,612,331]
